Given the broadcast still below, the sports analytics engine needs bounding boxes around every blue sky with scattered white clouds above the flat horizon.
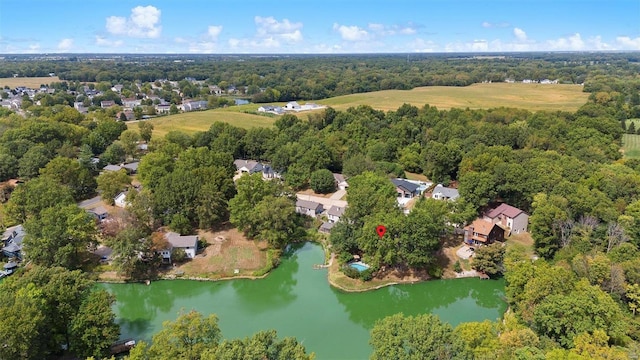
[0,0,640,54]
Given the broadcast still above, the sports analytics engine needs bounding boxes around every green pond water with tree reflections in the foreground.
[100,243,506,359]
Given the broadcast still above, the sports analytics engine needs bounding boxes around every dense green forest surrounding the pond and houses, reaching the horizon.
[0,54,640,359]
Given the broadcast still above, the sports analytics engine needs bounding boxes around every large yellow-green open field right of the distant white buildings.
[318,83,589,111]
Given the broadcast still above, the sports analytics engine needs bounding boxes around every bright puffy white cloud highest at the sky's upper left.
[106,6,162,38]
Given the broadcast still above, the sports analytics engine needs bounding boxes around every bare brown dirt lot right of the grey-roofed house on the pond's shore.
[172,228,267,279]
